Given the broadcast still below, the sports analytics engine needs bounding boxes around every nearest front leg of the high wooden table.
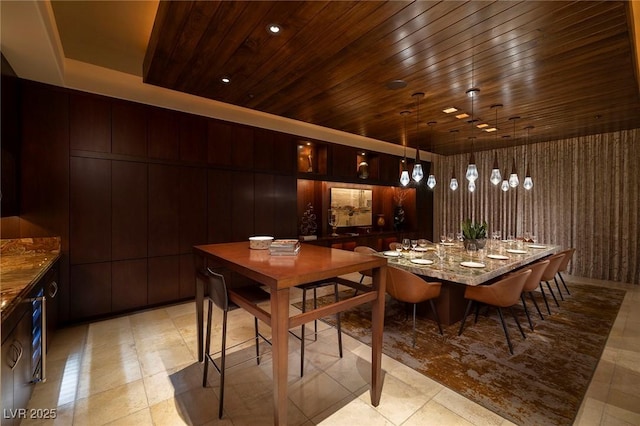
[271,288,289,425]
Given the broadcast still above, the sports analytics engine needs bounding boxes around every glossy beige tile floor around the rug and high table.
[22,277,640,426]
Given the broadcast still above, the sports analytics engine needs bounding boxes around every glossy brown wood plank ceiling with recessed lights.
[143,0,640,155]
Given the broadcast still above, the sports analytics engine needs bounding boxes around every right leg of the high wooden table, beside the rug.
[371,266,387,407]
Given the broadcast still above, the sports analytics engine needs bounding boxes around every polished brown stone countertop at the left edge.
[0,237,60,321]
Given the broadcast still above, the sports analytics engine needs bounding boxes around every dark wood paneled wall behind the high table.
[16,81,436,323]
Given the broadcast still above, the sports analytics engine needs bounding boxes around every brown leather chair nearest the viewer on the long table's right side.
[458,269,531,355]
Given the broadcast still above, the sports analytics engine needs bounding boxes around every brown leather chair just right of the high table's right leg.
[386,266,443,347]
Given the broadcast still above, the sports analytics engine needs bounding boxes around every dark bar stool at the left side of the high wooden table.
[198,269,271,419]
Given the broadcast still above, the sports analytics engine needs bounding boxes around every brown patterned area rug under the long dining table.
[302,283,625,425]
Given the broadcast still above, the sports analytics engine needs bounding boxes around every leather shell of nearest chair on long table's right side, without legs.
[464,269,531,308]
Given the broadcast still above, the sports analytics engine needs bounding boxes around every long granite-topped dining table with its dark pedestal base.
[380,240,559,325]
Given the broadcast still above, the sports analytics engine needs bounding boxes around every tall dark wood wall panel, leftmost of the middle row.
[69,157,111,264]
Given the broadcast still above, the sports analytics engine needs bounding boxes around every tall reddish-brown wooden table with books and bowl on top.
[193,242,387,425]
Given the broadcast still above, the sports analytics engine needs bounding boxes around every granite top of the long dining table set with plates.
[381,241,560,286]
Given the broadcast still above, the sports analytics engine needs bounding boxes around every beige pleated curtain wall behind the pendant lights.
[433,129,640,284]
